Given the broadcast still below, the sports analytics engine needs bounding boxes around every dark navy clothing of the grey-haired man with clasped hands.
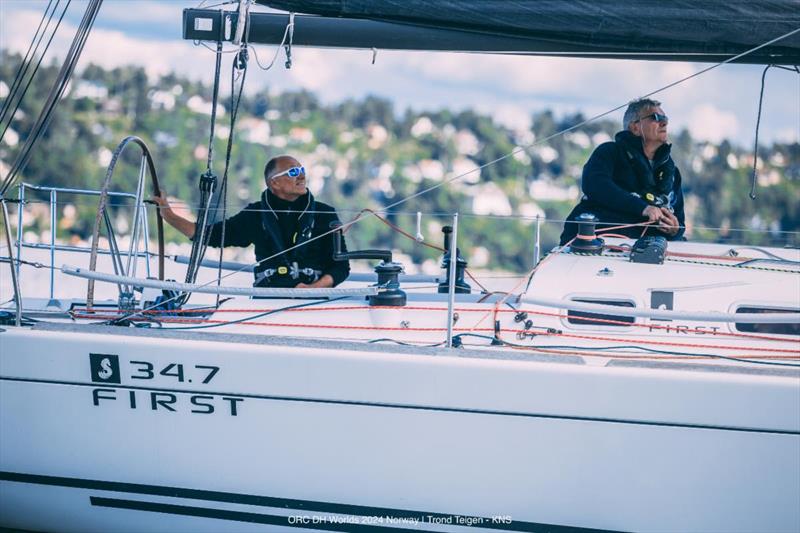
[561,131,685,246]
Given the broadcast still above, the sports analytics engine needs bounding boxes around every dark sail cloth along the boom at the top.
[250,0,800,65]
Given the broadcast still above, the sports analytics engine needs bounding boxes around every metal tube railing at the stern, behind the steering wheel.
[16,182,150,300]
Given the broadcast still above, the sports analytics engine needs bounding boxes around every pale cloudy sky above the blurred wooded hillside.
[0,0,800,149]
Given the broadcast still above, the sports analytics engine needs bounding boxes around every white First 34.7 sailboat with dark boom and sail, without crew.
[0,0,800,532]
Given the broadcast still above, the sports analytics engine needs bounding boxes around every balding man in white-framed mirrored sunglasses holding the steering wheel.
[153,155,350,288]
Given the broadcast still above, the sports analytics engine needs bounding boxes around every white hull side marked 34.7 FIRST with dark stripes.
[0,325,800,531]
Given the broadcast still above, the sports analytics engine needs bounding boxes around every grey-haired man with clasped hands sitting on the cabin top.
[561,98,685,246]
